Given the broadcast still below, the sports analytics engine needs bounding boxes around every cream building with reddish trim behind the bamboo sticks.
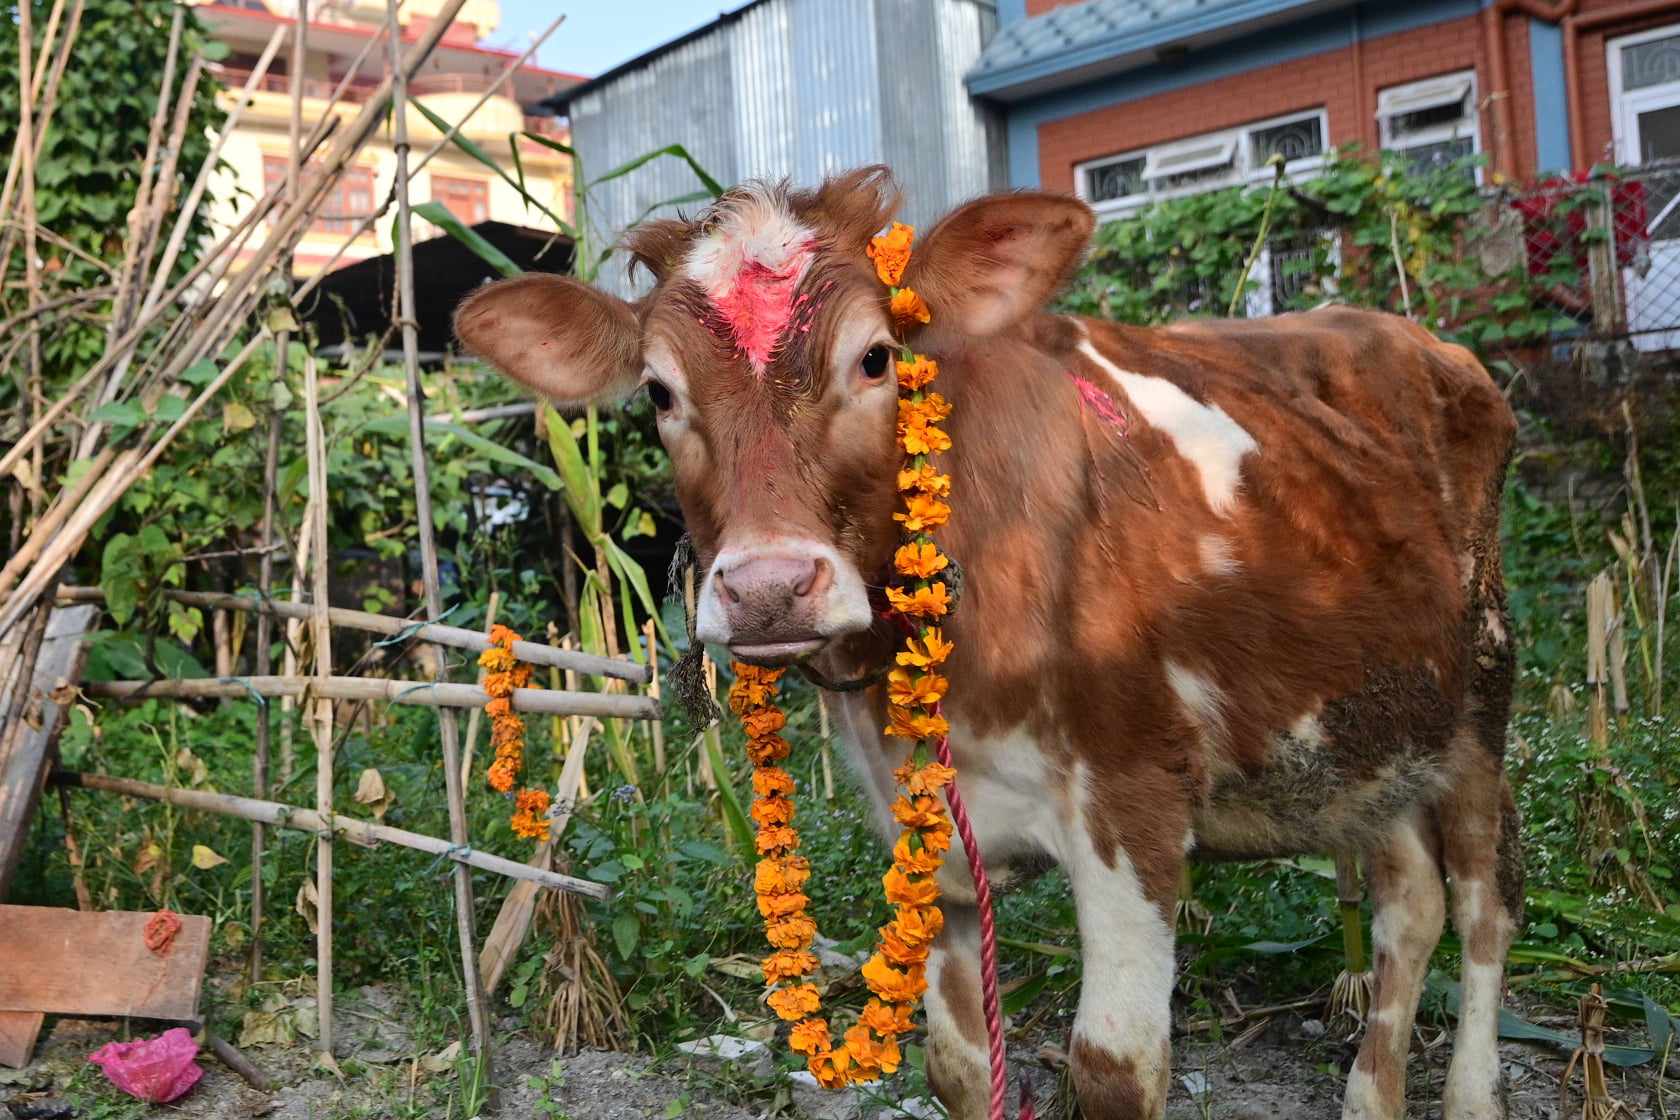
[198,0,583,275]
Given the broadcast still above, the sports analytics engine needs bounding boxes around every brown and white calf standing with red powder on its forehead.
[457,168,1522,1120]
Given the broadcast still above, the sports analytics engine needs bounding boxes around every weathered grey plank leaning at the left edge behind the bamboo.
[0,606,99,898]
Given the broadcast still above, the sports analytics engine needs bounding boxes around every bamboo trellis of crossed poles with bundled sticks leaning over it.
[0,0,621,1075]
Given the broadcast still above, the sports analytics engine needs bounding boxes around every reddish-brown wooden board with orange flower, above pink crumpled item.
[0,905,210,1023]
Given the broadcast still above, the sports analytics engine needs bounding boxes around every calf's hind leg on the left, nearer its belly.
[1342,811,1446,1120]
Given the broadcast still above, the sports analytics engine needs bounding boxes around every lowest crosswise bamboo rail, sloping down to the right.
[52,771,610,900]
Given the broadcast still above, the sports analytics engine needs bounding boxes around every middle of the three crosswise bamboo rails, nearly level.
[82,677,660,719]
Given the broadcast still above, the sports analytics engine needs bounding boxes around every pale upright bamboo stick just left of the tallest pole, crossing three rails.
[302,352,333,1055]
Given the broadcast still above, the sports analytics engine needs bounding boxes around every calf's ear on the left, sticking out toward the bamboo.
[455,274,642,406]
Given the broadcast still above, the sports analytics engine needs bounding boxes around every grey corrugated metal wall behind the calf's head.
[571,0,1006,290]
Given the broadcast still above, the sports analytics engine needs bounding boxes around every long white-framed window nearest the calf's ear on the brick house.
[1075,109,1327,218]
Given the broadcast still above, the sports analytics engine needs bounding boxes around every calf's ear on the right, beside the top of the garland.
[906,191,1097,338]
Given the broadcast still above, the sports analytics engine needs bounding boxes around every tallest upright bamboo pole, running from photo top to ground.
[385,0,494,1067]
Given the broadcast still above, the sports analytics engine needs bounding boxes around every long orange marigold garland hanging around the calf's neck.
[729,222,956,1088]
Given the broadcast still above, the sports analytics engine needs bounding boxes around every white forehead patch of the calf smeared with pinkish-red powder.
[684,191,816,373]
